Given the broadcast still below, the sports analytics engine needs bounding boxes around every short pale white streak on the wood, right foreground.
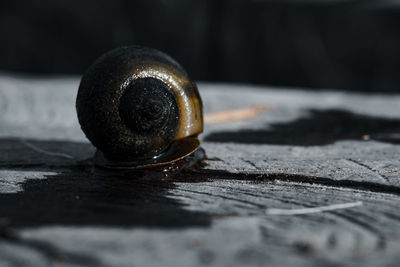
[266,201,363,215]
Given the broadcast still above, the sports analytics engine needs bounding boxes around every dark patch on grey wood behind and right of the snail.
[205,110,400,146]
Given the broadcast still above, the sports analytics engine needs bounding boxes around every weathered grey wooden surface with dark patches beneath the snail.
[0,75,400,266]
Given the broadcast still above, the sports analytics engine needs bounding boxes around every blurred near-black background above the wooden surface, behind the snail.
[0,0,400,92]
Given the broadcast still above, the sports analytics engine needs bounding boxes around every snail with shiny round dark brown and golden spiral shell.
[76,46,203,168]
